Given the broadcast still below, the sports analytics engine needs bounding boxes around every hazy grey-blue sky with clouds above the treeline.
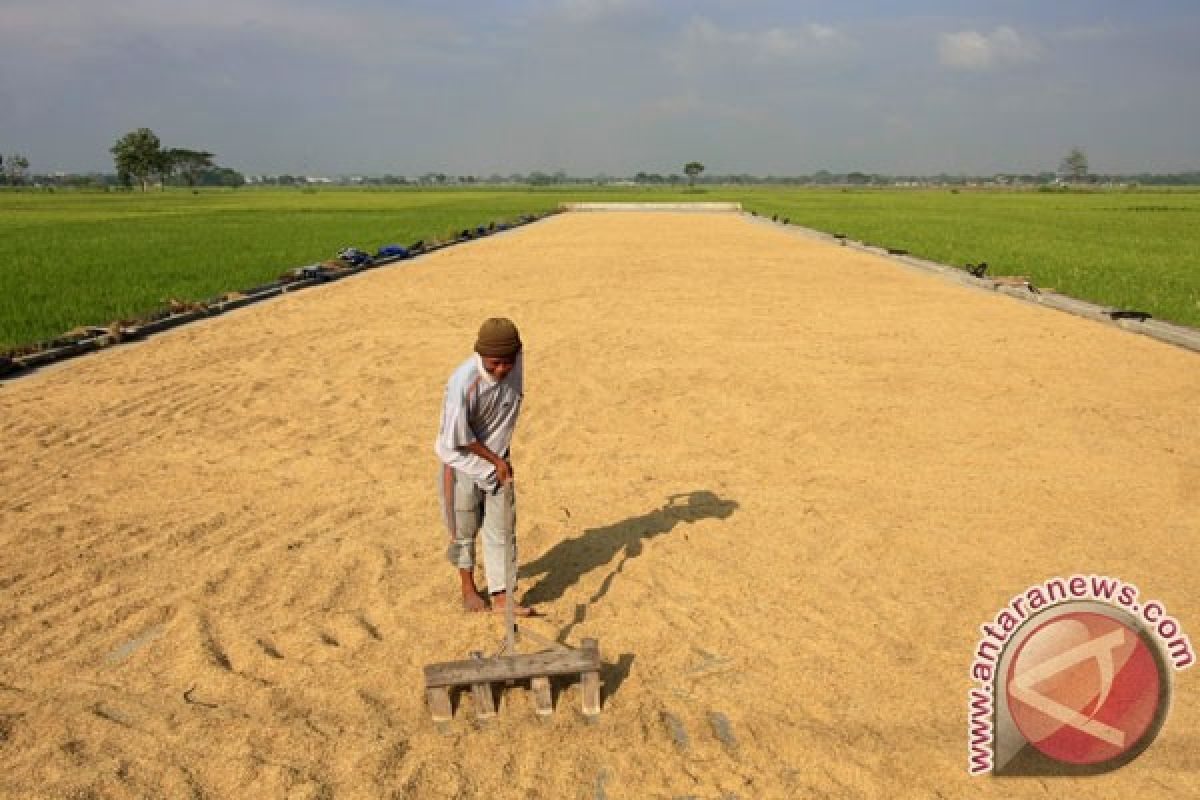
[0,0,1200,175]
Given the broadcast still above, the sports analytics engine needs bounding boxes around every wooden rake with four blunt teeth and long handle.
[425,482,600,730]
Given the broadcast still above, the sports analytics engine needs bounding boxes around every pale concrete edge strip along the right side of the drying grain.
[743,213,1200,353]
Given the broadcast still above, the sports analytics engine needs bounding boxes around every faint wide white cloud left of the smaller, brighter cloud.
[667,17,854,72]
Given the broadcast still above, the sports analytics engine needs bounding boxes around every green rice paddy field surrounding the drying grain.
[0,187,1200,353]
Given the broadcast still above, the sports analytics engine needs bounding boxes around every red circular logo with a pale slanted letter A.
[1006,610,1164,764]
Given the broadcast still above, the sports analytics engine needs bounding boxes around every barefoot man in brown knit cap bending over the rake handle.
[434,318,534,616]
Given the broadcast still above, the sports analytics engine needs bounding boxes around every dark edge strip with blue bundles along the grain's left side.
[0,211,558,384]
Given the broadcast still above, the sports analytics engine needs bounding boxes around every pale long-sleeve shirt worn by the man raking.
[433,353,524,492]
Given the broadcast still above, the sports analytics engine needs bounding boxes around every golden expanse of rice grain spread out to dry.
[0,213,1200,800]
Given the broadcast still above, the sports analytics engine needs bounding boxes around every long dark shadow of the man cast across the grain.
[520,489,738,604]
